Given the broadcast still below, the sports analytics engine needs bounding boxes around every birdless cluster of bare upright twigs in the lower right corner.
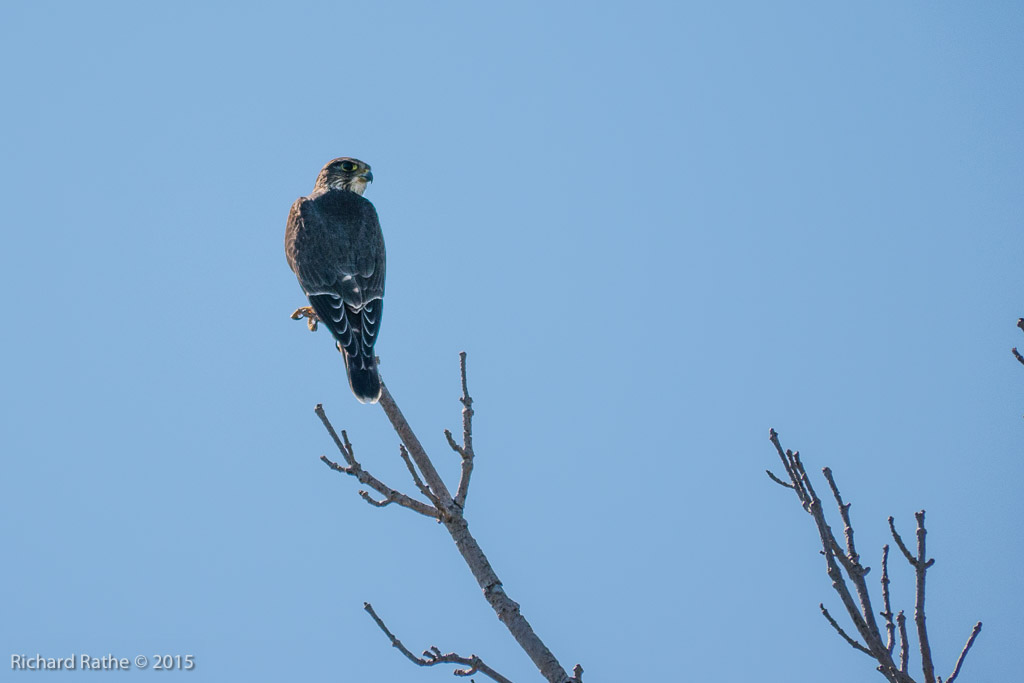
[768,430,983,683]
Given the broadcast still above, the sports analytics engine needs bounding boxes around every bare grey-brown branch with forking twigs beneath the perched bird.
[311,356,583,683]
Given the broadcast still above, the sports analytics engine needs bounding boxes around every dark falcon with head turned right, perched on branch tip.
[285,157,384,403]
